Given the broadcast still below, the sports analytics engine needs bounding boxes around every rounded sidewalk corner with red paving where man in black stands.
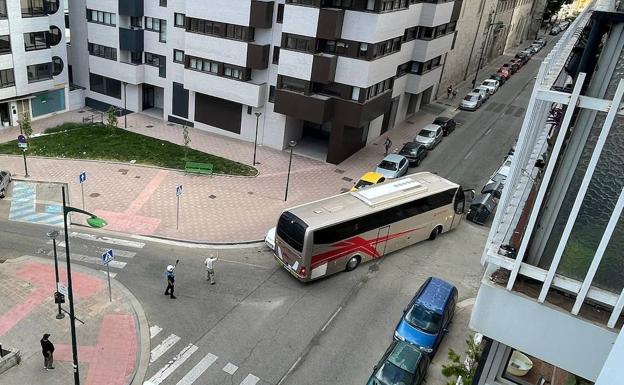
[0,256,150,385]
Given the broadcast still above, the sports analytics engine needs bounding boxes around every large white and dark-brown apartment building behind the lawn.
[69,0,462,163]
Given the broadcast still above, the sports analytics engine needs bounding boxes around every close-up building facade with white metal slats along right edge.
[470,0,624,385]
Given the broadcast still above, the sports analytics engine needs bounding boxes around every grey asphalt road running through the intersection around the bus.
[0,42,545,385]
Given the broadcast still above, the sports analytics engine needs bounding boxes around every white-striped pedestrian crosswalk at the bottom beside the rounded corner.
[143,325,260,385]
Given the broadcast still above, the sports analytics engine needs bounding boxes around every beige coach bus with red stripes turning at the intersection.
[273,172,472,282]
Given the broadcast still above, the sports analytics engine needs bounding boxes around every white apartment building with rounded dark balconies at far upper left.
[0,0,69,129]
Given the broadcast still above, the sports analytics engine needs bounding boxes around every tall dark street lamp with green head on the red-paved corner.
[61,186,107,385]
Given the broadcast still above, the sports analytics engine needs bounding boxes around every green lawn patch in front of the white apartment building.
[0,123,257,176]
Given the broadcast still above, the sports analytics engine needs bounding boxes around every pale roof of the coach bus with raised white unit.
[286,172,459,229]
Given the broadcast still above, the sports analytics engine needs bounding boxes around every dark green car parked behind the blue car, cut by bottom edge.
[366,341,429,385]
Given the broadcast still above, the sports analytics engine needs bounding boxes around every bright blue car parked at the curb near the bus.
[394,277,457,356]
